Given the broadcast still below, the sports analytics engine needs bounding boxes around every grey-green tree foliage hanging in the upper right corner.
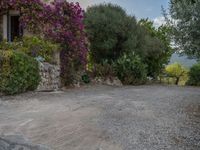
[165,0,200,59]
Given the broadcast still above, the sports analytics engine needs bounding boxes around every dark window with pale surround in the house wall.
[0,10,23,42]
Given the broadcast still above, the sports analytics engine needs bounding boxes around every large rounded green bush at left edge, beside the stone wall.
[0,50,40,95]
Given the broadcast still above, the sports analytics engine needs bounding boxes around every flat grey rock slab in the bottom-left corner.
[0,135,50,150]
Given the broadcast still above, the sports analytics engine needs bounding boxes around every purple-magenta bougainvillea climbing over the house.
[0,0,87,84]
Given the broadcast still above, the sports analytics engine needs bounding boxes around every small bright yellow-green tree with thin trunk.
[165,63,188,85]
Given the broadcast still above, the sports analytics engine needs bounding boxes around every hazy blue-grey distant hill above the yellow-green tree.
[170,53,197,68]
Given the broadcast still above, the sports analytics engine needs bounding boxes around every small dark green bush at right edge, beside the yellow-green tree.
[187,63,200,86]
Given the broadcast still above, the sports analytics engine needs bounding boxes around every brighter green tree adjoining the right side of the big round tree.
[138,19,173,79]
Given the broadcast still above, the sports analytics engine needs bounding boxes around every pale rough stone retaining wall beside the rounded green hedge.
[37,62,61,91]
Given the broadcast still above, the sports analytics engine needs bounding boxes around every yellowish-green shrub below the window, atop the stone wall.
[0,36,59,63]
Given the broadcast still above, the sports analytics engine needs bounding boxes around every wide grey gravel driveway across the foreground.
[0,85,200,150]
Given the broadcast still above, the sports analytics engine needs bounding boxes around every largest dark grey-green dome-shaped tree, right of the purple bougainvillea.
[84,4,137,64]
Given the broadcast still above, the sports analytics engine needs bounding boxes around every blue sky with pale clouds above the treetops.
[69,0,169,26]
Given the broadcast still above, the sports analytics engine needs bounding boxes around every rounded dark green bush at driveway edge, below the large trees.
[114,53,147,85]
